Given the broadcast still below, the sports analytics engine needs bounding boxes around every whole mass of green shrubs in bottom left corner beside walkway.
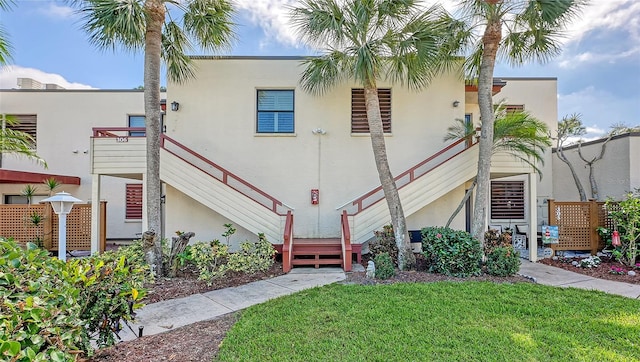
[0,238,148,361]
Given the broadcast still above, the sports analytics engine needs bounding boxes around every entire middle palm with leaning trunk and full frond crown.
[292,0,460,269]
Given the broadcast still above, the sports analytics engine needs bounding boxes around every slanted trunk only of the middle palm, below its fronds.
[364,83,415,270]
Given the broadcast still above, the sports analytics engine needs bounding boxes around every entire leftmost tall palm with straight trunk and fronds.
[68,0,233,275]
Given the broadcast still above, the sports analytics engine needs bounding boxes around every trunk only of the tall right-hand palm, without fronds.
[471,18,502,245]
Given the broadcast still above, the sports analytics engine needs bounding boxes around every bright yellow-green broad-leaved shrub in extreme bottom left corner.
[0,239,91,361]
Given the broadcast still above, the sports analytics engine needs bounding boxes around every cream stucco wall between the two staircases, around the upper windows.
[166,58,464,239]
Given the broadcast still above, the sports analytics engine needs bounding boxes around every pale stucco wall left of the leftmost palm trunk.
[0,90,158,239]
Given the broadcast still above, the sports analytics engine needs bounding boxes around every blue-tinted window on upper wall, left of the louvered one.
[256,89,295,133]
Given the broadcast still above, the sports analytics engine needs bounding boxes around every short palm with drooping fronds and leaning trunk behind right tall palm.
[444,105,551,227]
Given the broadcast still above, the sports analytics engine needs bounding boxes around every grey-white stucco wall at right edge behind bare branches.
[553,133,640,201]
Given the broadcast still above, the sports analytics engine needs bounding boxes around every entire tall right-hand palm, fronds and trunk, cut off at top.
[462,0,586,241]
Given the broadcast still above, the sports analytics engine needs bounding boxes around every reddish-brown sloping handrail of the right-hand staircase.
[343,137,478,215]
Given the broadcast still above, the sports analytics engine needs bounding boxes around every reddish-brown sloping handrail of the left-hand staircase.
[160,134,285,216]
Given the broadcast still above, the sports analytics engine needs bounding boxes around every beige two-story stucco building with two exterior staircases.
[0,57,557,264]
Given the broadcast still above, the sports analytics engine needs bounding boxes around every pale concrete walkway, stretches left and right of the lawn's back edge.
[121,260,640,341]
